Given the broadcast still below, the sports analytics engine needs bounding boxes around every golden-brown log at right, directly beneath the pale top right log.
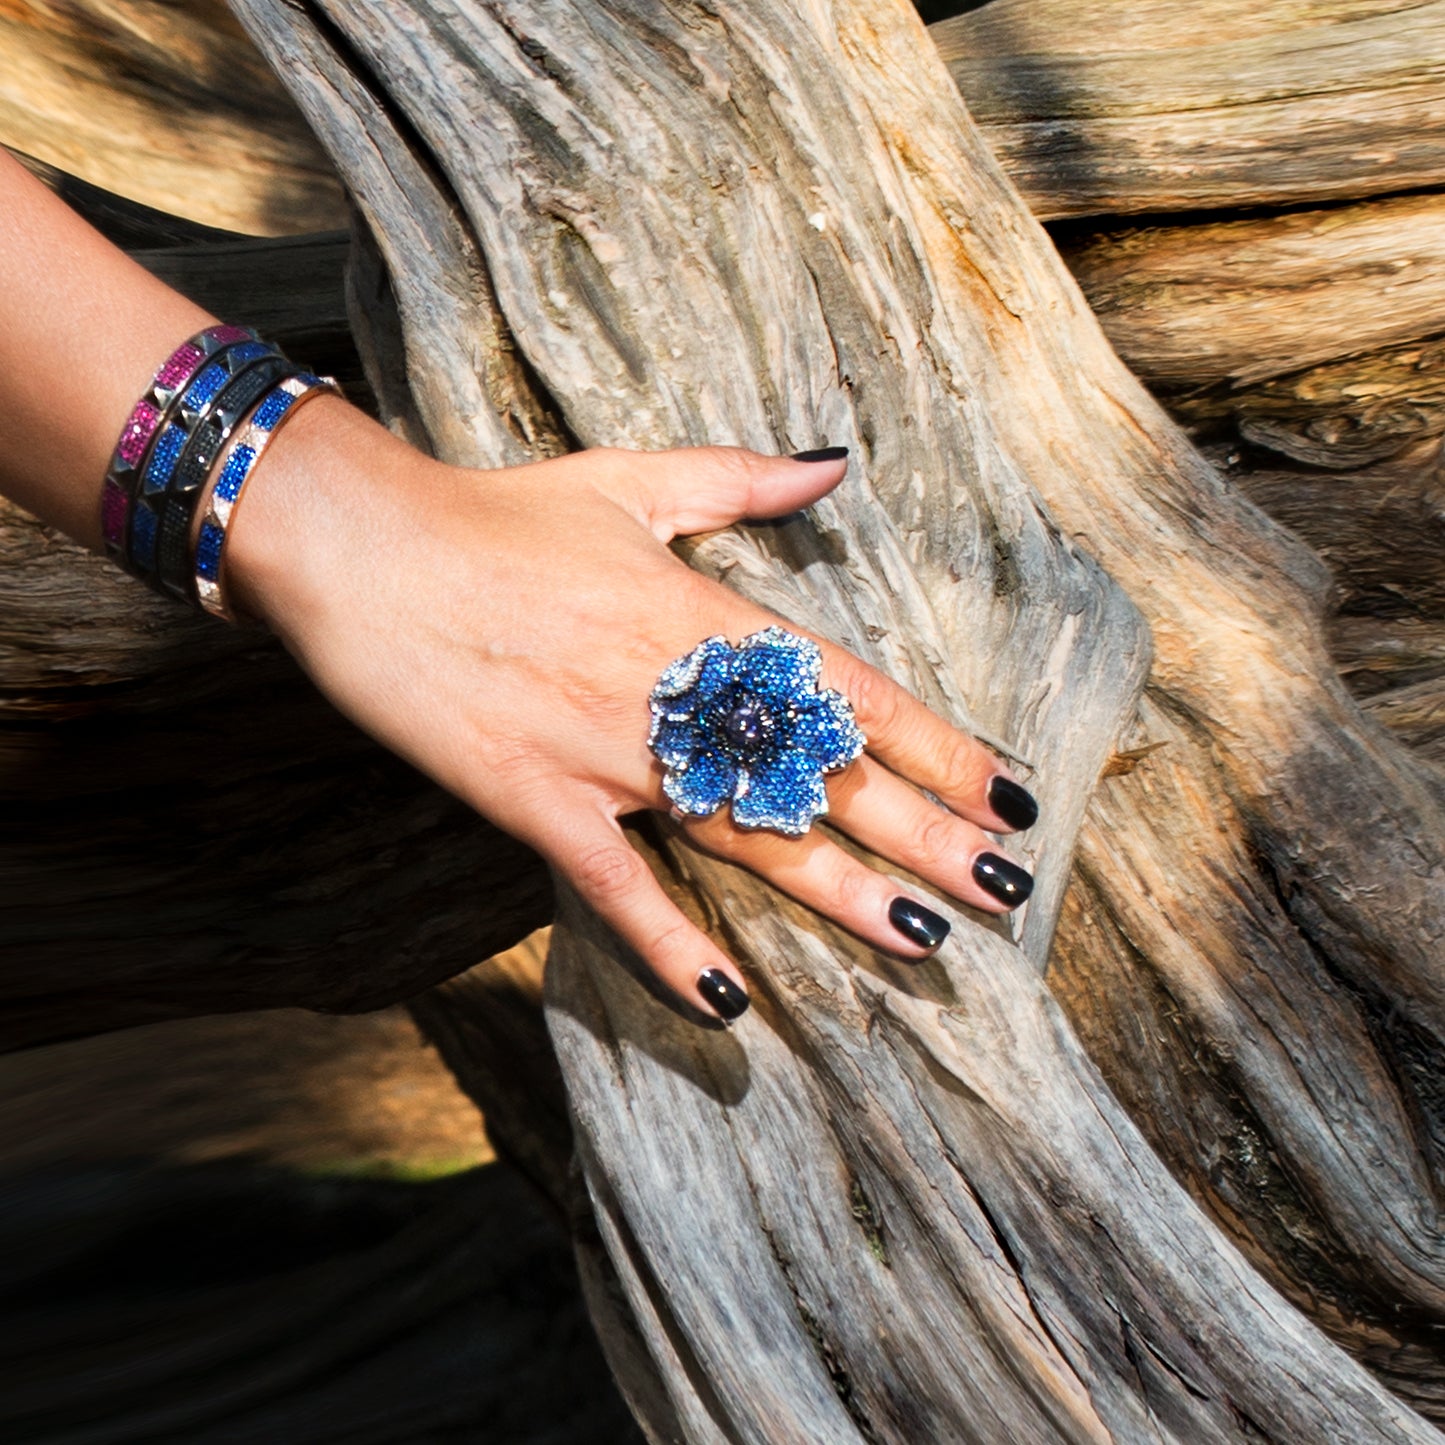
[1055,192,1445,471]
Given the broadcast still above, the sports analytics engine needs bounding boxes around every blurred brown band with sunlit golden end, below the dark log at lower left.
[0,1009,493,1173]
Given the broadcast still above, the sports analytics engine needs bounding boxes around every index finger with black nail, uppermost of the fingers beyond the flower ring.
[824,643,1039,832]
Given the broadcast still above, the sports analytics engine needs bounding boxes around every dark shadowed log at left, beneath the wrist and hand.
[0,507,551,1048]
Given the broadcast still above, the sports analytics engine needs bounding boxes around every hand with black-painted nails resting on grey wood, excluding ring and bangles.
[225,399,1035,1017]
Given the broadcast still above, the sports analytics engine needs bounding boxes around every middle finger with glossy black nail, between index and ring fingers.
[828,757,1033,913]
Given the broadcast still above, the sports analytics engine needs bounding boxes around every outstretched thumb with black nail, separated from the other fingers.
[604,447,848,542]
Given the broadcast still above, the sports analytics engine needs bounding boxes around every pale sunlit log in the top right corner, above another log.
[931,0,1445,220]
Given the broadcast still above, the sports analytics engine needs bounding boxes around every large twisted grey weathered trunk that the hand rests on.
[209,0,1445,1445]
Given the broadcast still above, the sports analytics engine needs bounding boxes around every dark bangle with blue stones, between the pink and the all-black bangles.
[117,335,290,585]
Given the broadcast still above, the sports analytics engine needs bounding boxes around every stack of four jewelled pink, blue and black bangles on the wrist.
[101,325,335,617]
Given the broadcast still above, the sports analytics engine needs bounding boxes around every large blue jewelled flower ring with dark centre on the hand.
[647,627,867,838]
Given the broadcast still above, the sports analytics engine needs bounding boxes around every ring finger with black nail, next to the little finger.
[682,814,949,961]
